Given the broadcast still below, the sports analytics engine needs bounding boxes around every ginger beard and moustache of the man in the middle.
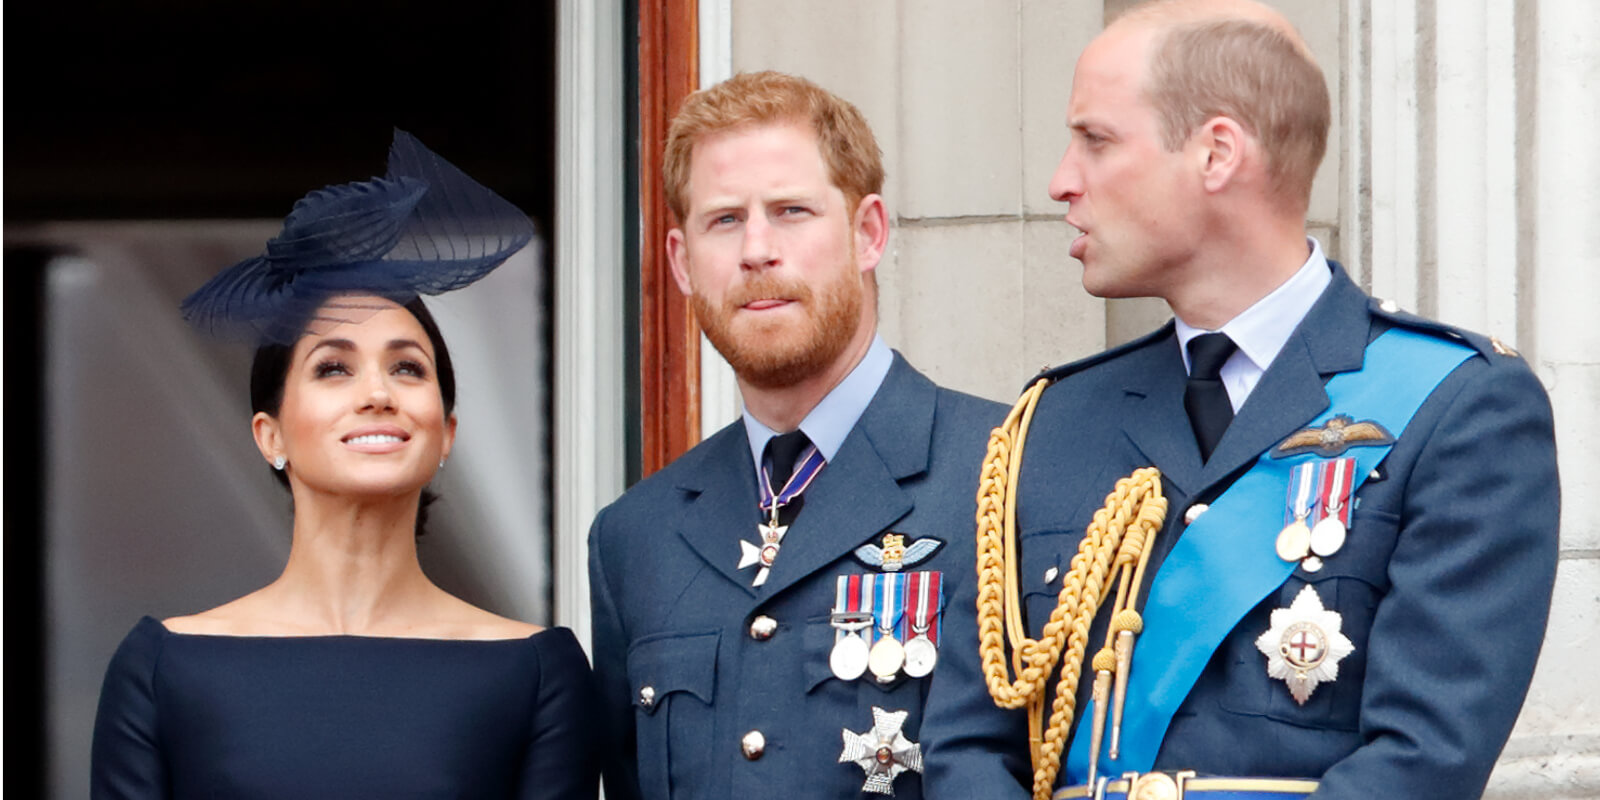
[691,249,866,389]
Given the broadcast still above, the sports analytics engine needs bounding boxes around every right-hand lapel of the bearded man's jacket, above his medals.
[758,354,936,597]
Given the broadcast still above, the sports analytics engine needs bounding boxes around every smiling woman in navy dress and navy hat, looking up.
[91,131,597,800]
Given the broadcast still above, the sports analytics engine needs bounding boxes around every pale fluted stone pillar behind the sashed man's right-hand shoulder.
[1341,0,1600,798]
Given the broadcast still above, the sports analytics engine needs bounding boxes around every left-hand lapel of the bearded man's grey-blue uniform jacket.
[677,422,755,597]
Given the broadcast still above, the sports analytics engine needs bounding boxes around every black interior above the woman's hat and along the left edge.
[3,0,555,797]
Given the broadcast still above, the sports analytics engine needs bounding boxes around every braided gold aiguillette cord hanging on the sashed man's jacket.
[978,379,1166,800]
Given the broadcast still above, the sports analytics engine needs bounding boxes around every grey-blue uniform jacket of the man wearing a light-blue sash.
[925,264,1558,800]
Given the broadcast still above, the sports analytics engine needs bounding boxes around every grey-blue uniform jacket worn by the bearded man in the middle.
[589,354,1005,800]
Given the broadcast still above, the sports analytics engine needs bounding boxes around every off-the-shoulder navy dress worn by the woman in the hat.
[91,618,597,800]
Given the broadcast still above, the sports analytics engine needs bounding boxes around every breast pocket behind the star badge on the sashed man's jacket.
[1221,509,1400,731]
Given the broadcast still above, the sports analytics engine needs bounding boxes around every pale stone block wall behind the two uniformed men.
[729,0,1600,798]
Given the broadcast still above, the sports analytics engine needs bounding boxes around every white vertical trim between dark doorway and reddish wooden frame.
[554,0,626,646]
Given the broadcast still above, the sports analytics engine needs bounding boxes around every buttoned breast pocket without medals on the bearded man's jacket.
[627,630,722,798]
